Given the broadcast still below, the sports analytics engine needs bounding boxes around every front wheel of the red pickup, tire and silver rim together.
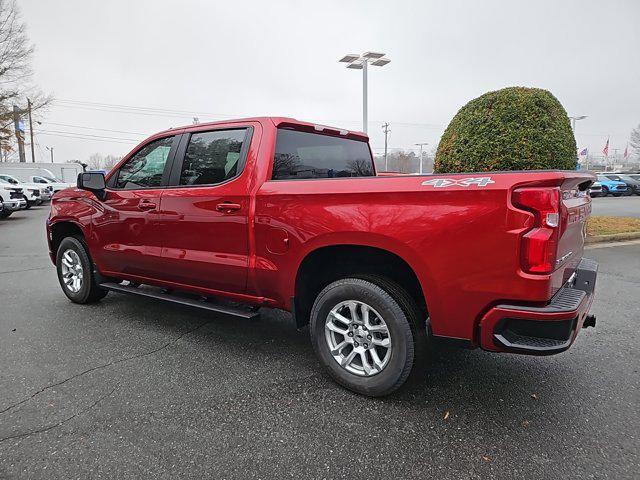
[56,237,108,303]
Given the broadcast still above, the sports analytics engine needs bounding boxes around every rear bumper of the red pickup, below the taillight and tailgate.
[480,258,598,355]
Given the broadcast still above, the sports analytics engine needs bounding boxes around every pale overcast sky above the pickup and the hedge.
[19,0,640,161]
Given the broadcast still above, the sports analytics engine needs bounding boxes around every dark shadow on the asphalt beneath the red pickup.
[91,294,588,418]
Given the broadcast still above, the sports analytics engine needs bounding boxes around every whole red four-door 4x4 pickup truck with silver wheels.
[47,117,597,396]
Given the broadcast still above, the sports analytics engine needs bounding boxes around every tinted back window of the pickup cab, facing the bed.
[271,129,374,180]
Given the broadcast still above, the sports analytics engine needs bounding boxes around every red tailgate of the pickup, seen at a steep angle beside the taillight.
[553,173,592,291]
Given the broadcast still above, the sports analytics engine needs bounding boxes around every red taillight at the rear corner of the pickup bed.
[513,187,560,274]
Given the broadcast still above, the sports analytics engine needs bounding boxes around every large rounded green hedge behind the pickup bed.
[434,87,576,173]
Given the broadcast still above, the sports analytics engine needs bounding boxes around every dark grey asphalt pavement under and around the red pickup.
[0,208,640,479]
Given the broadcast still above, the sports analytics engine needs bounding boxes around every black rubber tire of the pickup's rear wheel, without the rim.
[310,275,426,397]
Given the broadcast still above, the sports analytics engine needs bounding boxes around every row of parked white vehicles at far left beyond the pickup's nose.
[0,173,72,220]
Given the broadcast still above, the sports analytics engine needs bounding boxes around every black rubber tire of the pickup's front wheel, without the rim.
[56,237,109,304]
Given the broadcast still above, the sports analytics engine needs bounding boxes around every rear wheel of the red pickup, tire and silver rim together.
[310,278,419,397]
